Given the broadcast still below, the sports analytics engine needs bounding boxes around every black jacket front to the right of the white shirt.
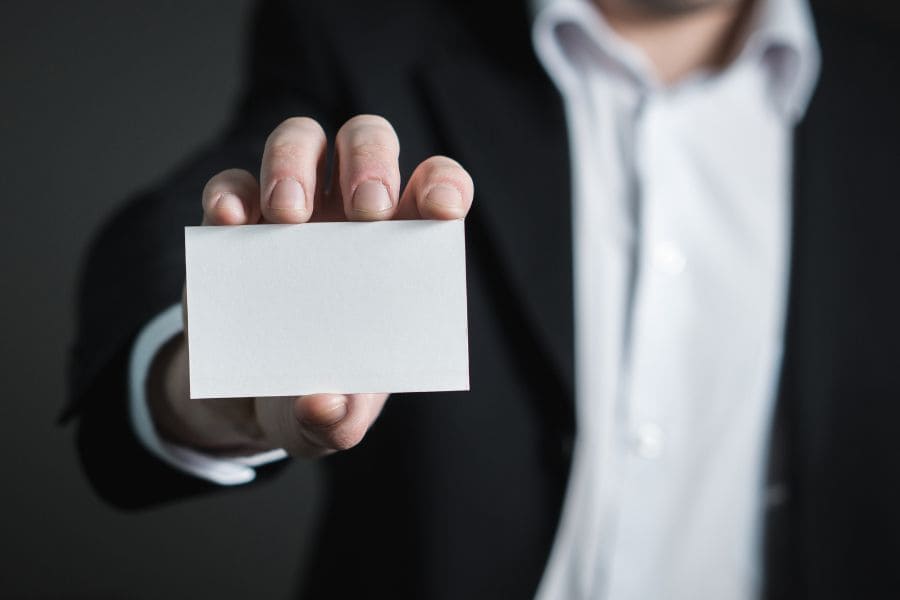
[773,4,900,598]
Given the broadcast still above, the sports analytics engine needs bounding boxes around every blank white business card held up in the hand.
[184,221,469,398]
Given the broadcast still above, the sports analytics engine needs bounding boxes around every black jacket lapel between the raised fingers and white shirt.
[421,44,574,398]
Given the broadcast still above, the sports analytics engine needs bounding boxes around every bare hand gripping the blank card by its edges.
[148,115,474,457]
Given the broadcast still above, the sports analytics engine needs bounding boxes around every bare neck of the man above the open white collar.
[594,0,756,84]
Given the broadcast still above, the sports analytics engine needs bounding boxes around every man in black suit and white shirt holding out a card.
[69,0,900,599]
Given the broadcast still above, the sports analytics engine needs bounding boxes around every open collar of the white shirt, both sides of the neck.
[528,0,821,122]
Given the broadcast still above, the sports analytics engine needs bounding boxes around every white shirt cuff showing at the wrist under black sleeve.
[128,304,287,485]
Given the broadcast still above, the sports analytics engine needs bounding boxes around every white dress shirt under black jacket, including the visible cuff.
[130,0,819,600]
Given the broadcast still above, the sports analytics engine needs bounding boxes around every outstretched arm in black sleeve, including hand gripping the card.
[70,3,473,506]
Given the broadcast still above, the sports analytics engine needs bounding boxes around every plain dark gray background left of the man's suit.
[0,0,318,598]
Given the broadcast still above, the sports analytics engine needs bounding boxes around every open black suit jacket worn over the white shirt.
[67,0,900,599]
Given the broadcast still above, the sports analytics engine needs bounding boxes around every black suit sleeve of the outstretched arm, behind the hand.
[61,1,346,508]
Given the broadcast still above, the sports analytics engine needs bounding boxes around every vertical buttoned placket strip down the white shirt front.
[605,92,690,600]
